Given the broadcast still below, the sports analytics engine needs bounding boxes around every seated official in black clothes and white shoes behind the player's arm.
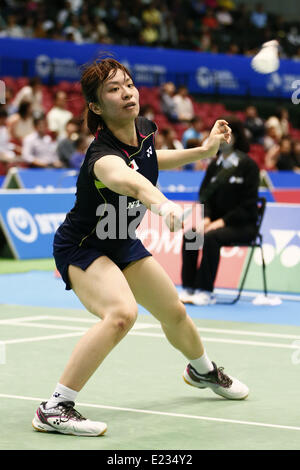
[180,118,259,305]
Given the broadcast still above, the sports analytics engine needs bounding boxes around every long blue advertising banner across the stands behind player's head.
[0,38,300,98]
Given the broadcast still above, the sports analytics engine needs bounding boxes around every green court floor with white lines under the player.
[0,305,300,450]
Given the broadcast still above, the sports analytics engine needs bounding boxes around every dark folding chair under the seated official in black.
[217,197,267,305]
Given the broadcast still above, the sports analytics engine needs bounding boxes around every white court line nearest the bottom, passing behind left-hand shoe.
[0,393,300,431]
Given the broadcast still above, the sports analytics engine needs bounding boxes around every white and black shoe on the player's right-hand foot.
[183,362,249,400]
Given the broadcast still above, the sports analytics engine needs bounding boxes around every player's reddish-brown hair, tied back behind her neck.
[80,57,132,135]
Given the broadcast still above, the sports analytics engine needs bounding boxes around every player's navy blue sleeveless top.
[57,117,158,249]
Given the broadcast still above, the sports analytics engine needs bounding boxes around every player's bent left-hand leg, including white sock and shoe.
[32,256,137,436]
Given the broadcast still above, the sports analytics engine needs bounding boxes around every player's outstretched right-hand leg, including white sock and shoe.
[123,257,249,399]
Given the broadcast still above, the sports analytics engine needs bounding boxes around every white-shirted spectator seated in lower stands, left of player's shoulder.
[22,116,62,168]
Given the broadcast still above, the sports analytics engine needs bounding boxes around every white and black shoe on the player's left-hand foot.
[32,401,107,436]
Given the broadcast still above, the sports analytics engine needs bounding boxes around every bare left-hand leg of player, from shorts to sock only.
[60,256,137,391]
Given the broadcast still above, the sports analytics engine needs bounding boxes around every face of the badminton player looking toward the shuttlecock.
[99,70,140,123]
